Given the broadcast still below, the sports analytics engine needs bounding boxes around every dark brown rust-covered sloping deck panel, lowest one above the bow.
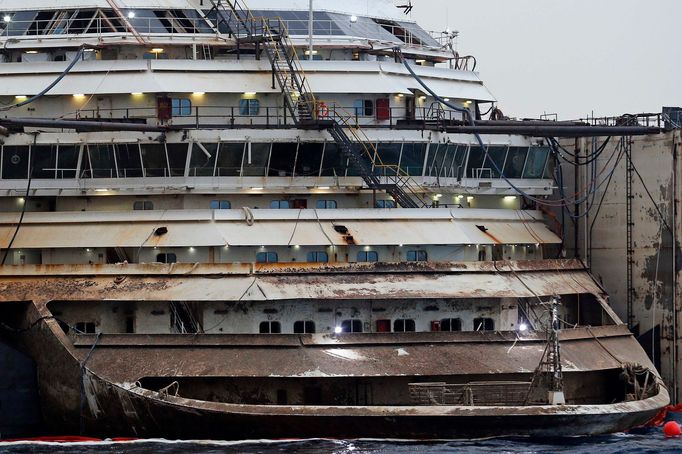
[67,327,650,383]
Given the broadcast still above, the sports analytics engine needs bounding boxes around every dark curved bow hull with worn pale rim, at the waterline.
[9,294,669,439]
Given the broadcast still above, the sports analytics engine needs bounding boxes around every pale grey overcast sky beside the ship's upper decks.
[412,0,682,119]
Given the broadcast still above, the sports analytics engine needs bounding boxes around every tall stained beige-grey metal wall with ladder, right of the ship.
[563,130,682,401]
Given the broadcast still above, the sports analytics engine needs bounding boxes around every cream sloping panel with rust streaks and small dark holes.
[0,210,561,249]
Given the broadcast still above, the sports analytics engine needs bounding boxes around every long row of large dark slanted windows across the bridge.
[0,142,553,183]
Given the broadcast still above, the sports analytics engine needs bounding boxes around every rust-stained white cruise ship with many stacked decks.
[0,0,669,439]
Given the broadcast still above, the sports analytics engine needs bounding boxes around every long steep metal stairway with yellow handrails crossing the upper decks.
[206,0,426,208]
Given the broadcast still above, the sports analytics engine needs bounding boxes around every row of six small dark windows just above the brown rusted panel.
[259,317,495,334]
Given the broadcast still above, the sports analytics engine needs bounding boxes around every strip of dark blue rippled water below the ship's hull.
[0,429,682,454]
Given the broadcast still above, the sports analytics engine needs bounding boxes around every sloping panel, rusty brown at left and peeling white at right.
[0,270,601,302]
